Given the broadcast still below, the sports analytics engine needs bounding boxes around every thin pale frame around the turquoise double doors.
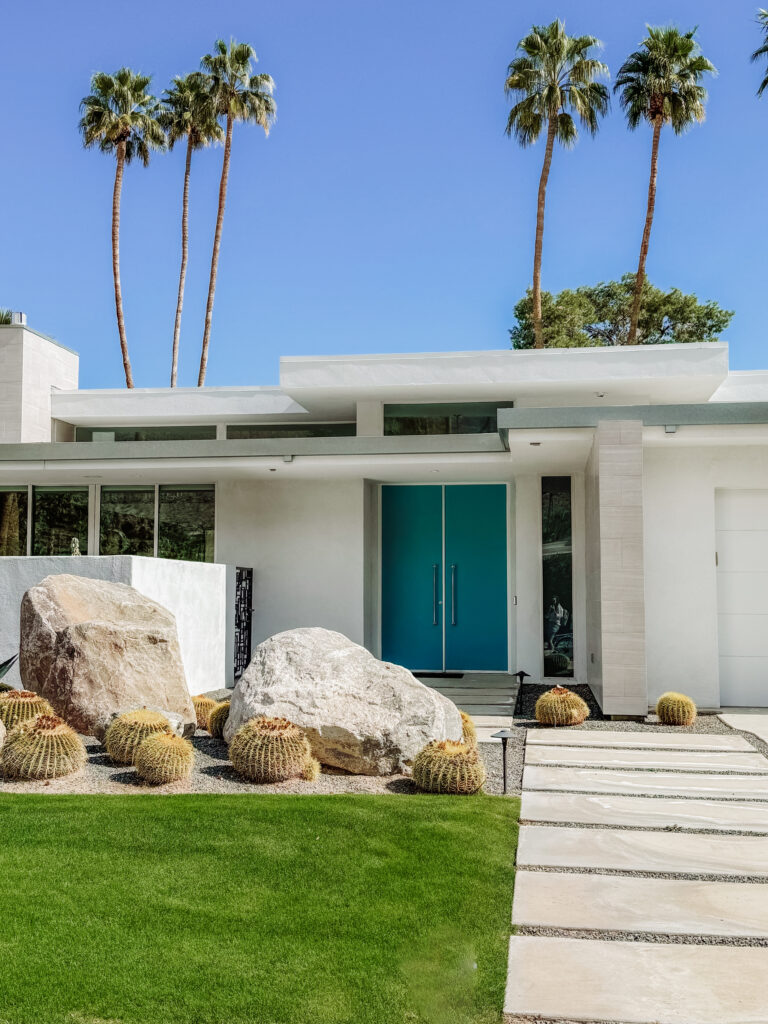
[375,479,517,675]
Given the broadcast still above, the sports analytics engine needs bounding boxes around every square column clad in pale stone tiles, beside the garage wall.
[586,420,648,715]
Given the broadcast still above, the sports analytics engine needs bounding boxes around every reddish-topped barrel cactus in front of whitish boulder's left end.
[229,718,319,782]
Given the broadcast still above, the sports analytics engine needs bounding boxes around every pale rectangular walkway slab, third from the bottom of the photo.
[517,825,768,878]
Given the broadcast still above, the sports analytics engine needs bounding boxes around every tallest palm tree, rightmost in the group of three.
[198,39,275,387]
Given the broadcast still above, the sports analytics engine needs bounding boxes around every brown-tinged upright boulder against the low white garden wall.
[19,574,196,739]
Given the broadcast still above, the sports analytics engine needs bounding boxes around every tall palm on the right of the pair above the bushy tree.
[613,26,717,345]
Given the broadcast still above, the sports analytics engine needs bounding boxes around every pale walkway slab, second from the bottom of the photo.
[512,870,768,937]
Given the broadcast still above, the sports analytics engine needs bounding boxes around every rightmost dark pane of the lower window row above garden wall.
[158,484,216,562]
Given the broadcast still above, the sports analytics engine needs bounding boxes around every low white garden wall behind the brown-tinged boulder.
[0,555,231,694]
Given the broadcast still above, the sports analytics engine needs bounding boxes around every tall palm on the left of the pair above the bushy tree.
[504,20,610,348]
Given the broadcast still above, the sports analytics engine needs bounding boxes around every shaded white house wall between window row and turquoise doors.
[216,479,367,646]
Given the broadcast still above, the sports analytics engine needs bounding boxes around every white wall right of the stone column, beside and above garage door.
[644,440,768,708]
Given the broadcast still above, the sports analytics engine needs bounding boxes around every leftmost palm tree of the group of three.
[80,68,165,388]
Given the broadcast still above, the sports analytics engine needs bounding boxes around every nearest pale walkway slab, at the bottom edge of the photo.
[504,935,768,1024]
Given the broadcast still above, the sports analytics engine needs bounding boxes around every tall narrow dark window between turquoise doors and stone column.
[542,476,573,677]
